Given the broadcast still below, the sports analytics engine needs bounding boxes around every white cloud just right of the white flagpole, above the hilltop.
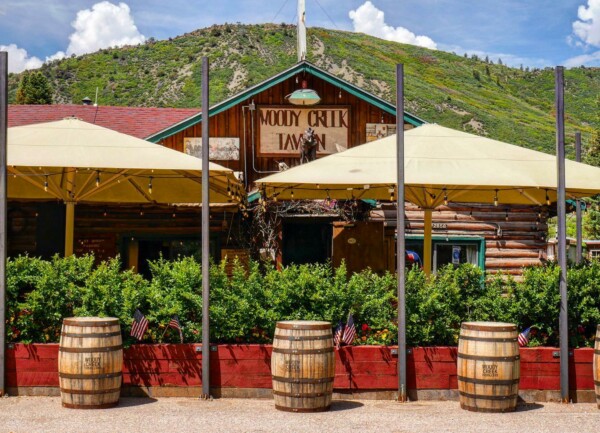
[348,0,436,50]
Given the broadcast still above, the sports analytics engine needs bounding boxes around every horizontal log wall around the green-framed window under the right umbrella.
[371,203,548,277]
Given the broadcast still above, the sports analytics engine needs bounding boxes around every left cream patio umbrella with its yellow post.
[7,118,242,255]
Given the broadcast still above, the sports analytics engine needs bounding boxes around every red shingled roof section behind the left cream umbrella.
[8,105,201,138]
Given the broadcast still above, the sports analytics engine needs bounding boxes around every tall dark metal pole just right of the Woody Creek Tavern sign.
[396,64,407,402]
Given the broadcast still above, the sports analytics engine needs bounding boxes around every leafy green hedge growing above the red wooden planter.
[7,256,600,346]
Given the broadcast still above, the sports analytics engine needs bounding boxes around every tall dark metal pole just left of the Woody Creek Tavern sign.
[202,57,210,399]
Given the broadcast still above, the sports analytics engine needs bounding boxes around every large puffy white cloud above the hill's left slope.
[67,1,146,56]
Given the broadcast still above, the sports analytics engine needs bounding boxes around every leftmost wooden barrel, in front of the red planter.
[58,317,123,409]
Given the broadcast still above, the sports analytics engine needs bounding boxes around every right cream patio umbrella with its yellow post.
[257,124,600,272]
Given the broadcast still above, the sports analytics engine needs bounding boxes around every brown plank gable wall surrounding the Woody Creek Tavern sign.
[155,74,412,187]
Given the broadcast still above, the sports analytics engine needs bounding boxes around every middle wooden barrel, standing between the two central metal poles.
[271,320,335,412]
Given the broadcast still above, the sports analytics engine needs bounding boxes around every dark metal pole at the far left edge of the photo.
[0,51,8,396]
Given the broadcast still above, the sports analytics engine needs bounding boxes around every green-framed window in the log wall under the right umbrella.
[406,236,485,272]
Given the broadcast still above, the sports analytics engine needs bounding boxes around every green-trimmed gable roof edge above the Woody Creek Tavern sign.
[147,60,427,143]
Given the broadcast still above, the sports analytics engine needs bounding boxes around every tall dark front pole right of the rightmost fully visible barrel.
[555,66,569,403]
